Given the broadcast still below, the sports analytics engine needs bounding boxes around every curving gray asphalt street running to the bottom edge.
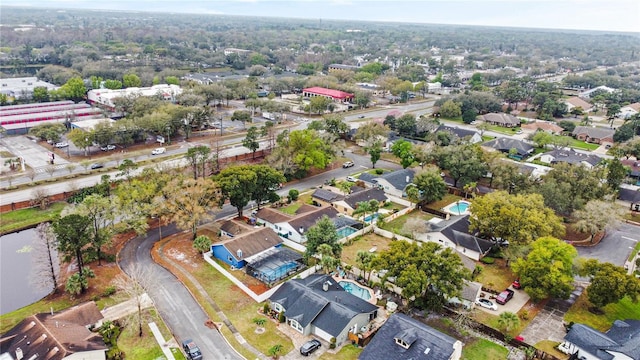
[118,225,243,360]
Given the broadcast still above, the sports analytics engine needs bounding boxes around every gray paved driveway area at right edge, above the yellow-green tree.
[576,223,640,266]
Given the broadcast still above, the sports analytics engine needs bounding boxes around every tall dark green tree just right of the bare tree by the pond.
[52,214,91,293]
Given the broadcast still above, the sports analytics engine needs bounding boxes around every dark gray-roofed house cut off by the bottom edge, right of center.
[358,313,462,360]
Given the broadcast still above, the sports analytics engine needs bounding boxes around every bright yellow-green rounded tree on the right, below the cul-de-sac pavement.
[511,237,578,302]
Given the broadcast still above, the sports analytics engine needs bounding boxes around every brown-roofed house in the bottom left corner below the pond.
[0,301,108,360]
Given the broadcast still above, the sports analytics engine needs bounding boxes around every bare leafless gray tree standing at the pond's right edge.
[29,223,60,292]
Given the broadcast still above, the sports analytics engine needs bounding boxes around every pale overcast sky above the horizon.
[12,0,640,32]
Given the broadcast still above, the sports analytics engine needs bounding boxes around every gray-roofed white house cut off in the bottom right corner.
[559,319,640,360]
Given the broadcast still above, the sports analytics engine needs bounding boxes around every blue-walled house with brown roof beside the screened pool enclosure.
[211,228,282,269]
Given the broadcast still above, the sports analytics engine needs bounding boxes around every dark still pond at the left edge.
[0,229,50,315]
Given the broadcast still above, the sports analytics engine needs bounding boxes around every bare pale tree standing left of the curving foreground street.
[113,264,156,337]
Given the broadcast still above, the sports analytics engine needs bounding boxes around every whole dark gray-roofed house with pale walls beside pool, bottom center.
[269,274,379,345]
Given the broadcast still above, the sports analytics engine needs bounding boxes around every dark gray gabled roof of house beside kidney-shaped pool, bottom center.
[269,274,378,336]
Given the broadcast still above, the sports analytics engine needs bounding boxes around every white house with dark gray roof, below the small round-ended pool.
[418,215,493,260]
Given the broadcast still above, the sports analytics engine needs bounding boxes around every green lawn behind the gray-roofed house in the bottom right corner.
[564,290,640,331]
